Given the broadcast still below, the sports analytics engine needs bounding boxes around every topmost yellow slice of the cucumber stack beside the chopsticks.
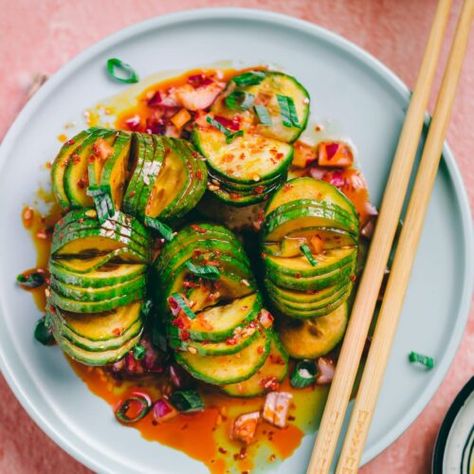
[265,177,359,223]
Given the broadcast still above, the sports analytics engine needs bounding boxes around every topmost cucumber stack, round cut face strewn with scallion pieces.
[193,71,309,207]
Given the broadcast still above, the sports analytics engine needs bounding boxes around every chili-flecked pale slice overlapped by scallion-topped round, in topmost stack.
[193,124,293,184]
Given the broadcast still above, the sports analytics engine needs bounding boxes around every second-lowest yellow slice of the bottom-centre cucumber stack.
[176,332,271,385]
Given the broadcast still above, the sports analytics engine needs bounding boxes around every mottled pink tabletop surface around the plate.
[0,0,474,474]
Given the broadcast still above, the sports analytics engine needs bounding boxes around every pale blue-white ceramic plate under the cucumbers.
[0,9,472,474]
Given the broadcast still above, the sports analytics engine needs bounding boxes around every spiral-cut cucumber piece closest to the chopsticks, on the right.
[262,178,359,358]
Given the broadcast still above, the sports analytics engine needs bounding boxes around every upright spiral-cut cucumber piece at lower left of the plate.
[48,209,152,365]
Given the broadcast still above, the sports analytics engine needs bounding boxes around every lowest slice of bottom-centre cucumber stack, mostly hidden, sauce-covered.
[221,332,288,397]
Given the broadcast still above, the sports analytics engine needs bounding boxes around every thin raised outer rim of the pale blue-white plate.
[0,7,474,472]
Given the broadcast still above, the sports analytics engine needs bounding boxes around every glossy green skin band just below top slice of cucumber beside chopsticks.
[262,200,359,241]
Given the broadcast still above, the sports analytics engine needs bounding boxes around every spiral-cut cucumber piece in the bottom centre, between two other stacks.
[155,223,288,396]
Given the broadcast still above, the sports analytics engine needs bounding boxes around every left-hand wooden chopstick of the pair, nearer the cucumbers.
[307,0,451,474]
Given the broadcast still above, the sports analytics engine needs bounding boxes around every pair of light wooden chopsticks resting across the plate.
[307,0,474,474]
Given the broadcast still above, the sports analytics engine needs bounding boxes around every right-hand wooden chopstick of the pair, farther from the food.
[336,0,474,474]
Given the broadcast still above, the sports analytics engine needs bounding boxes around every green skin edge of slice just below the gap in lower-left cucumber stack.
[49,260,147,288]
